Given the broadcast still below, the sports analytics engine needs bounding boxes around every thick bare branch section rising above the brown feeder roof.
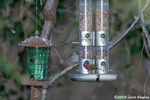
[41,0,59,38]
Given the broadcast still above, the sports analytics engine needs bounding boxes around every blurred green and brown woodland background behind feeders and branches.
[0,0,150,100]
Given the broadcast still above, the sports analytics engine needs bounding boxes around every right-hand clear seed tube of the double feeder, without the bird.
[95,0,109,74]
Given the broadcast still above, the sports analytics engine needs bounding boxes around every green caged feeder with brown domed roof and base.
[19,36,51,86]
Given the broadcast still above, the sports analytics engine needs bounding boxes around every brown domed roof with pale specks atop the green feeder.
[19,36,51,47]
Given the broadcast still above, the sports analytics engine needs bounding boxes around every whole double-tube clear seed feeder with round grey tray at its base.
[70,0,117,81]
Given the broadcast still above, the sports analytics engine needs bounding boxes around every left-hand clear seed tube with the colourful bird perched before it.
[79,0,95,74]
